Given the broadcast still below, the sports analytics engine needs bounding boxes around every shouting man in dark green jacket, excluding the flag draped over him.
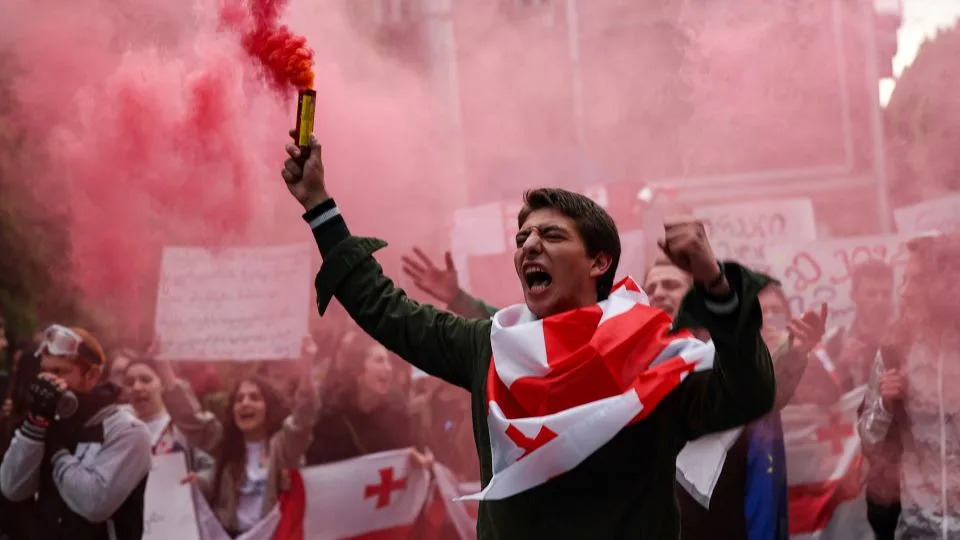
[283,133,775,539]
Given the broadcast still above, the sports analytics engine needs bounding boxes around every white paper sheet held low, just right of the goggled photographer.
[143,452,200,540]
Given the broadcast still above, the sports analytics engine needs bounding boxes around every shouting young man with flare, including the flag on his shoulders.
[282,134,774,539]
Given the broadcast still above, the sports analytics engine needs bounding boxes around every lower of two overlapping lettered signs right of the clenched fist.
[767,236,909,326]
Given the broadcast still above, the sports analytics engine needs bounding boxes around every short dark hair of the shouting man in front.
[517,188,620,301]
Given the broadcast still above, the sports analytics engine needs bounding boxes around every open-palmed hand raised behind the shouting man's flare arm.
[402,247,498,319]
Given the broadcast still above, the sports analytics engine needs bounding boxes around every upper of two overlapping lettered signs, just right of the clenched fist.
[693,199,817,272]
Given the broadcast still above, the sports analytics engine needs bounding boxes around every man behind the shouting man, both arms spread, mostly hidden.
[403,248,825,540]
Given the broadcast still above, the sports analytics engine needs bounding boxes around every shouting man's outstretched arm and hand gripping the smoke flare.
[282,136,490,388]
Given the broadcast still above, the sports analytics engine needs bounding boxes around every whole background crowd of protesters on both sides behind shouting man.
[0,158,960,539]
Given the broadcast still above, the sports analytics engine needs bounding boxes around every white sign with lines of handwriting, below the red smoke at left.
[156,244,311,360]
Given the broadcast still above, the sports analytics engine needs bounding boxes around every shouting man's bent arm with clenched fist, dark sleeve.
[660,218,776,440]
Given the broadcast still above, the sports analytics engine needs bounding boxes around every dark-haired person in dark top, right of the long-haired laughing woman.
[307,334,416,465]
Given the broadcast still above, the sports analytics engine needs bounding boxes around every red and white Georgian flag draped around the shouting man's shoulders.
[465,277,725,499]
